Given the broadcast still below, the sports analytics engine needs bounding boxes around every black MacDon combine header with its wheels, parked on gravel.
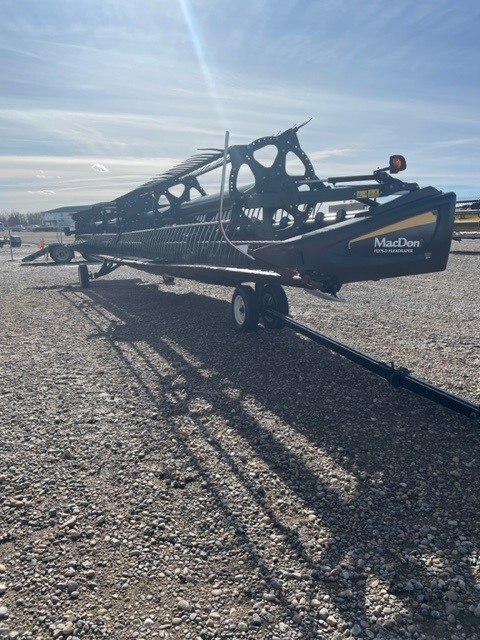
[26,125,455,331]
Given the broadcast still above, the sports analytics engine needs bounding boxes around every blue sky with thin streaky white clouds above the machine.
[0,0,480,213]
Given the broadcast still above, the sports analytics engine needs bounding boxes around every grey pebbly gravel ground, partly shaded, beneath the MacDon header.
[0,238,480,640]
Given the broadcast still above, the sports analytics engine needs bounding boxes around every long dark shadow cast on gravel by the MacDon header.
[58,281,480,638]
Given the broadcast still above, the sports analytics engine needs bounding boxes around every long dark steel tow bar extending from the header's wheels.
[269,310,480,423]
